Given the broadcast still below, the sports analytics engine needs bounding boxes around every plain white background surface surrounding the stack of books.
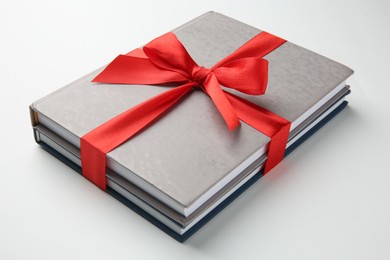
[0,0,390,260]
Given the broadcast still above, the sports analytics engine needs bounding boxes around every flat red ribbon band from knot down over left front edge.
[80,83,193,190]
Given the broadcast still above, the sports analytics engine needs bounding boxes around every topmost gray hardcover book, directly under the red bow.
[31,12,352,215]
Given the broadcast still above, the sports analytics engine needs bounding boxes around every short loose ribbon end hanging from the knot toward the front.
[204,73,240,131]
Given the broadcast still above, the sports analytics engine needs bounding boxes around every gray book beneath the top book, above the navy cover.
[34,86,349,234]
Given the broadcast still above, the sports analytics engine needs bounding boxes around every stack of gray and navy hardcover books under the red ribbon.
[30,12,353,241]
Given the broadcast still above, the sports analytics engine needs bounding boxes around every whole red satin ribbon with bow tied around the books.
[80,32,290,190]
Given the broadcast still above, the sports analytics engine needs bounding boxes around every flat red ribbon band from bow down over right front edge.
[225,92,291,174]
